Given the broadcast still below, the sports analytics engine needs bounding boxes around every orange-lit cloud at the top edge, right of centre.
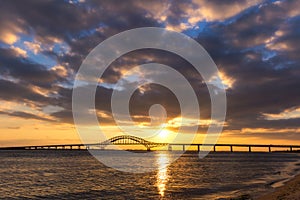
[136,0,262,31]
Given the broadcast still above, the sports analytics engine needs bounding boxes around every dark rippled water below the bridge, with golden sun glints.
[0,150,300,199]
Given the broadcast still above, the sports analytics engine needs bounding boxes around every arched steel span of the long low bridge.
[99,135,169,151]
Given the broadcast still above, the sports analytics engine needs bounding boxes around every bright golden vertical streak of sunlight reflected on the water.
[156,153,170,197]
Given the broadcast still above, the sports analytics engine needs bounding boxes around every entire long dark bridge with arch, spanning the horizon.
[0,135,300,152]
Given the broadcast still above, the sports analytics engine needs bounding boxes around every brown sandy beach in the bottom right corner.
[257,175,300,200]
